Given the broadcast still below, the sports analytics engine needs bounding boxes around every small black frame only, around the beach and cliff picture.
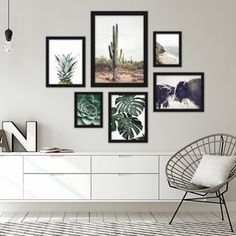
[153,31,182,67]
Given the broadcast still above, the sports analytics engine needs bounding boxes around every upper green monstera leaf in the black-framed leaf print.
[115,95,145,117]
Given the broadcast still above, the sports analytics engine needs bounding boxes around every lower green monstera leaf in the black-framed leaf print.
[118,113,143,140]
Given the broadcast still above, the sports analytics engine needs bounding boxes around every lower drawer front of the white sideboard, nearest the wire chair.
[92,174,158,200]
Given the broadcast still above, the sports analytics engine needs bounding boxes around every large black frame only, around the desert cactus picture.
[91,11,148,87]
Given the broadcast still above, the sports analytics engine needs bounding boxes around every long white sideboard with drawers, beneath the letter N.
[0,153,183,202]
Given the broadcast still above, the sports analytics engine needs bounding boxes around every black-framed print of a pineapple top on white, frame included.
[46,37,85,87]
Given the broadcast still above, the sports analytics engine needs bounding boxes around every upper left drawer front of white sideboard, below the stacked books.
[24,156,90,173]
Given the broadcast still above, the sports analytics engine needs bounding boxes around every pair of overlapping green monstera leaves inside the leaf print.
[110,94,146,141]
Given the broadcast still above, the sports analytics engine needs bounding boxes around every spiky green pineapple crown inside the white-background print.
[55,53,78,85]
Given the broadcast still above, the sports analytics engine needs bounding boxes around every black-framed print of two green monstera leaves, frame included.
[108,92,148,143]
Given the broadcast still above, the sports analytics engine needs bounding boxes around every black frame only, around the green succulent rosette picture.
[74,92,103,128]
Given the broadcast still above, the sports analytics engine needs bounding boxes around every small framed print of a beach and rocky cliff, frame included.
[153,31,182,67]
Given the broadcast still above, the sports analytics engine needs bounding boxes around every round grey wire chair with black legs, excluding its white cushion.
[166,133,236,232]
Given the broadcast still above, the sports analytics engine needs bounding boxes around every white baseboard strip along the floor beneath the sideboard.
[0,201,236,212]
